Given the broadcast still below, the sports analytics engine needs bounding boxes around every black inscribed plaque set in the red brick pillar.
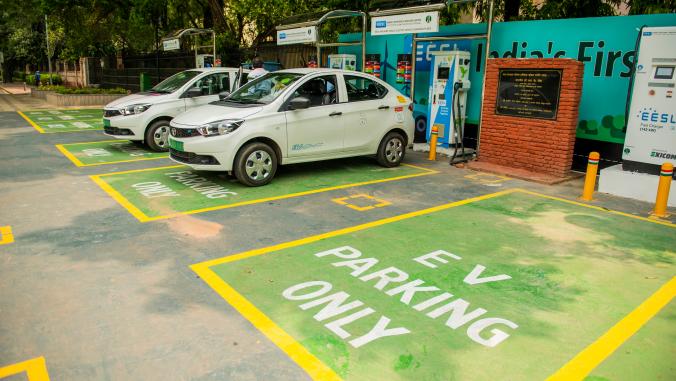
[495,69,562,119]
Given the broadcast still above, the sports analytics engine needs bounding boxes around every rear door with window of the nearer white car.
[343,74,394,151]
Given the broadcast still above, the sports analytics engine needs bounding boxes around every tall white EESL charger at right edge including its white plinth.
[599,27,676,207]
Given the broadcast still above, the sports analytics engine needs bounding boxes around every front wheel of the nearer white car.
[234,142,277,187]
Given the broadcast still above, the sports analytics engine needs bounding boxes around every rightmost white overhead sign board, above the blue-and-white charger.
[371,12,439,36]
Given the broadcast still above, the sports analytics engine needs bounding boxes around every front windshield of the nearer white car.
[225,73,303,104]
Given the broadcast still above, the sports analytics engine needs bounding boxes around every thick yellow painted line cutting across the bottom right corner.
[547,277,676,381]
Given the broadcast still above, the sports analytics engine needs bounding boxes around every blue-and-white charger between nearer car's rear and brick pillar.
[427,50,470,148]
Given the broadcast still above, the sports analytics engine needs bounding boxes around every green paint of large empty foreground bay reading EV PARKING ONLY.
[211,193,676,380]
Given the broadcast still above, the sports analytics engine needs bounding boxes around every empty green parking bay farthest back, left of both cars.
[18,109,103,134]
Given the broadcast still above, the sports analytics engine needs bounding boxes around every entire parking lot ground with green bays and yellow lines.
[0,95,676,381]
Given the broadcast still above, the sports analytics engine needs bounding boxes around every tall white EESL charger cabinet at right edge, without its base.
[622,27,676,174]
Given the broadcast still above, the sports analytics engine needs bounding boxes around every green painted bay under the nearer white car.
[95,158,436,221]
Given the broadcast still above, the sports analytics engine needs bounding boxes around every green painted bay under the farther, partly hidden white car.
[61,140,168,166]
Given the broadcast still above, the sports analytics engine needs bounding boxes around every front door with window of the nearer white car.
[285,75,344,158]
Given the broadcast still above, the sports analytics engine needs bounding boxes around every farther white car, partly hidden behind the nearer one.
[103,68,249,151]
